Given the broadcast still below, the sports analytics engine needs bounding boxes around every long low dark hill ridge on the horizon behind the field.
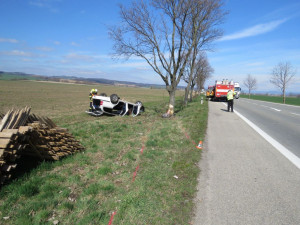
[0,71,169,88]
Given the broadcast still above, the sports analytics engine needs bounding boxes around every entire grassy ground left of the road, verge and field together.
[0,81,208,225]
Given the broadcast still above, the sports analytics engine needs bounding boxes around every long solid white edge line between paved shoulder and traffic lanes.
[220,103,300,169]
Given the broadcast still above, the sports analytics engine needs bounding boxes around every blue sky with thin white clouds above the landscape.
[0,0,300,93]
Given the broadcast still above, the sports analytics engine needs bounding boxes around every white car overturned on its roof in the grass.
[86,93,145,117]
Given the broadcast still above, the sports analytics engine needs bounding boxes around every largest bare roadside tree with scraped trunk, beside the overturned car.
[109,0,225,116]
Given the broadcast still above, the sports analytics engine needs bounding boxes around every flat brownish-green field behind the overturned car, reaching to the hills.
[0,80,172,124]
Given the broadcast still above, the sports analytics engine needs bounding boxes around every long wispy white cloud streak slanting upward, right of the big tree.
[219,19,287,41]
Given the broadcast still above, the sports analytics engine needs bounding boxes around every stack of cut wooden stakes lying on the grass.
[0,107,84,185]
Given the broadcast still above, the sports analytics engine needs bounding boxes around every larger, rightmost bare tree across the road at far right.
[270,62,296,104]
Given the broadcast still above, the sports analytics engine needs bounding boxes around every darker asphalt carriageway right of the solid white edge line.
[234,98,300,158]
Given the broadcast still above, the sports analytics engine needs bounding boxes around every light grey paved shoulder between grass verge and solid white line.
[192,101,300,225]
